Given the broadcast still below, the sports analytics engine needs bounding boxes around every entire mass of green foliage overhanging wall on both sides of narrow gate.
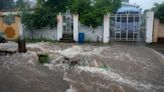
[22,0,121,31]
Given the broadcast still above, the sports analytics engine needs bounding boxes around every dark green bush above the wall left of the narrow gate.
[22,7,56,30]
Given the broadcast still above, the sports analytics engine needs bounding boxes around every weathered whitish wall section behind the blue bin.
[79,24,103,42]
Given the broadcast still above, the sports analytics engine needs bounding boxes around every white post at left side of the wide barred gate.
[103,14,110,43]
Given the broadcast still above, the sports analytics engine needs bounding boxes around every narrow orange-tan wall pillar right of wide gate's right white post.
[153,19,159,43]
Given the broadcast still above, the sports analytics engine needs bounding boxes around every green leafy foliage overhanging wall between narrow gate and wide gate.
[71,0,121,28]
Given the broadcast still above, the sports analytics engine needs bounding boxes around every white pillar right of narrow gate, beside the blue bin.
[73,14,79,42]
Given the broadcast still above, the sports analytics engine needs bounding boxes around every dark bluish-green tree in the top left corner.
[0,0,14,10]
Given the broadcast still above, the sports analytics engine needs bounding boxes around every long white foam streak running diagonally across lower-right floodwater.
[78,67,154,90]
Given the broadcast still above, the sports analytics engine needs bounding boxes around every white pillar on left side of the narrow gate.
[57,13,63,41]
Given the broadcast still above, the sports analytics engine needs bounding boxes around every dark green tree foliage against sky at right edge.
[152,3,164,23]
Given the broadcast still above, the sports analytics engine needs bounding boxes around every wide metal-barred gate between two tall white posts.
[109,14,146,41]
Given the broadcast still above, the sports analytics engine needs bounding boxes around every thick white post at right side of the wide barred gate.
[146,11,154,43]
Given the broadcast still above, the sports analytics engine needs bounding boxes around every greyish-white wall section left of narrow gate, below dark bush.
[24,27,57,40]
